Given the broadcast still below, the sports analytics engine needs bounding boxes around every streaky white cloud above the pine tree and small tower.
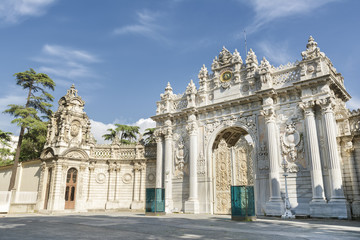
[33,44,100,81]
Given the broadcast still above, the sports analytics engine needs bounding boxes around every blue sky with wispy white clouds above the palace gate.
[0,0,360,140]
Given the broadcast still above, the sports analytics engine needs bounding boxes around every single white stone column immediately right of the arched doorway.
[261,105,284,216]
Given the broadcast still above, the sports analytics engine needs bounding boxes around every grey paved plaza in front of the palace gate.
[0,212,360,240]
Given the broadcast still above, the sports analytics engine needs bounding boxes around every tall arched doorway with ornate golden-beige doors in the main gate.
[212,127,255,214]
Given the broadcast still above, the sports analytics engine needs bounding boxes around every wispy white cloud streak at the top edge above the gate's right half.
[241,0,338,33]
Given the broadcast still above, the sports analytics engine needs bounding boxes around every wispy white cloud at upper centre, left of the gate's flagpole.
[113,10,168,42]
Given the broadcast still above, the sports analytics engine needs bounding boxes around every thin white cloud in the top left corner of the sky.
[0,0,55,24]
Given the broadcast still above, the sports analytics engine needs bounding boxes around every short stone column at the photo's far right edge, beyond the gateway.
[343,137,360,218]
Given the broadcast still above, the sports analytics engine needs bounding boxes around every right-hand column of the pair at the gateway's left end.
[164,120,173,213]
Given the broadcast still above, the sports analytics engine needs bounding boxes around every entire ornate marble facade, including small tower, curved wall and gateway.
[4,37,360,218]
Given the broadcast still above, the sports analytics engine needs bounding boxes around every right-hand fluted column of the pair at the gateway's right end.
[316,97,348,218]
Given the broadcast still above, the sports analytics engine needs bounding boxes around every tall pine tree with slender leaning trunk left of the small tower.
[4,68,55,191]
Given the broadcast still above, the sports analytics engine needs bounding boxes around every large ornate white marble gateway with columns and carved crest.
[152,37,354,218]
